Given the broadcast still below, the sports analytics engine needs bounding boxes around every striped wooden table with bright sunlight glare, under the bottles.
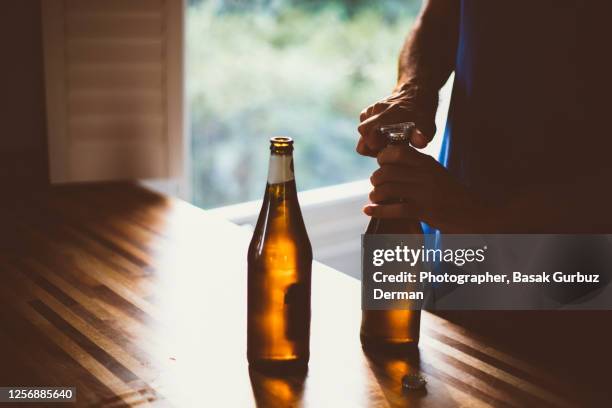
[0,184,610,407]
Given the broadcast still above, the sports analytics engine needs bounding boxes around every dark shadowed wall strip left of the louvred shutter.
[0,0,48,186]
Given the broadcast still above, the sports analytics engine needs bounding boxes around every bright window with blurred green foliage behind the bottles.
[186,0,430,208]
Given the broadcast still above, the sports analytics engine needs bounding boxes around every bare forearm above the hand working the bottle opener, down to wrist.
[396,0,459,93]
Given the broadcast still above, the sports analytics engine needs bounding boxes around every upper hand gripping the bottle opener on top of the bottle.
[357,87,437,157]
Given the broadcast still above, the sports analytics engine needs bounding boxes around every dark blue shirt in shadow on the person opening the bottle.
[440,0,612,202]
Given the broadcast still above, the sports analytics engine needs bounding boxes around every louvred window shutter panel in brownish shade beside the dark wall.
[41,0,185,183]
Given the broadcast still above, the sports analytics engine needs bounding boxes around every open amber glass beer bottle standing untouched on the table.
[247,137,312,368]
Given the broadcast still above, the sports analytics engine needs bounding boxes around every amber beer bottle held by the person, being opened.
[361,122,423,350]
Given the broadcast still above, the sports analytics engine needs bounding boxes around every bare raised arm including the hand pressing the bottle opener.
[357,0,459,156]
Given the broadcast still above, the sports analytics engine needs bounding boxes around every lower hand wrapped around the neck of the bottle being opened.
[364,145,481,232]
